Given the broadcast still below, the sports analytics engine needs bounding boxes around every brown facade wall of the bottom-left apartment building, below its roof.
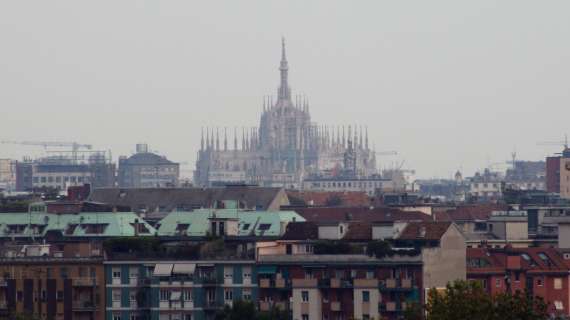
[0,259,105,320]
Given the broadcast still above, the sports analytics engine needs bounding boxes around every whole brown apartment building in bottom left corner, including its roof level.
[0,243,105,320]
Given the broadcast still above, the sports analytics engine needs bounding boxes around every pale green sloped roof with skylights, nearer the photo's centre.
[153,209,305,237]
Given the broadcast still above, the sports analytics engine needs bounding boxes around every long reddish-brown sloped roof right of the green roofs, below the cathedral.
[294,207,431,222]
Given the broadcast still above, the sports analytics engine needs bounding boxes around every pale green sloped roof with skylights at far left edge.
[0,212,155,238]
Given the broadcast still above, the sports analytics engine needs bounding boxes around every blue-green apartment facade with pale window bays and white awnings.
[105,261,257,320]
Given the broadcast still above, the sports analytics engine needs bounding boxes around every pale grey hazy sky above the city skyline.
[0,0,570,177]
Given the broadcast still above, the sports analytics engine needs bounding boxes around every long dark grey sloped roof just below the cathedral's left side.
[89,186,282,212]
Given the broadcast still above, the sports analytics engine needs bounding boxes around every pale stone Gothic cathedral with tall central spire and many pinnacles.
[194,41,377,188]
